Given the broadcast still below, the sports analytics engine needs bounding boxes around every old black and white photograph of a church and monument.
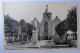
[2,2,78,50]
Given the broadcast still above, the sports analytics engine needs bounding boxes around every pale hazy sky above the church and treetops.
[3,2,77,22]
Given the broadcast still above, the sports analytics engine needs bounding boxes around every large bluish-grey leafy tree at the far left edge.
[4,15,18,43]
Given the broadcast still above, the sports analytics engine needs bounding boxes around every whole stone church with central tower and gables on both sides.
[32,5,60,40]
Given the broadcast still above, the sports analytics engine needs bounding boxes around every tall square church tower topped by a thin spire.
[40,5,52,40]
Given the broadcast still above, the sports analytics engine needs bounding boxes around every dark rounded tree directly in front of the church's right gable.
[55,20,68,37]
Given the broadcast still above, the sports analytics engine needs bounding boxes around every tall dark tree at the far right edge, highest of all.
[67,8,77,32]
